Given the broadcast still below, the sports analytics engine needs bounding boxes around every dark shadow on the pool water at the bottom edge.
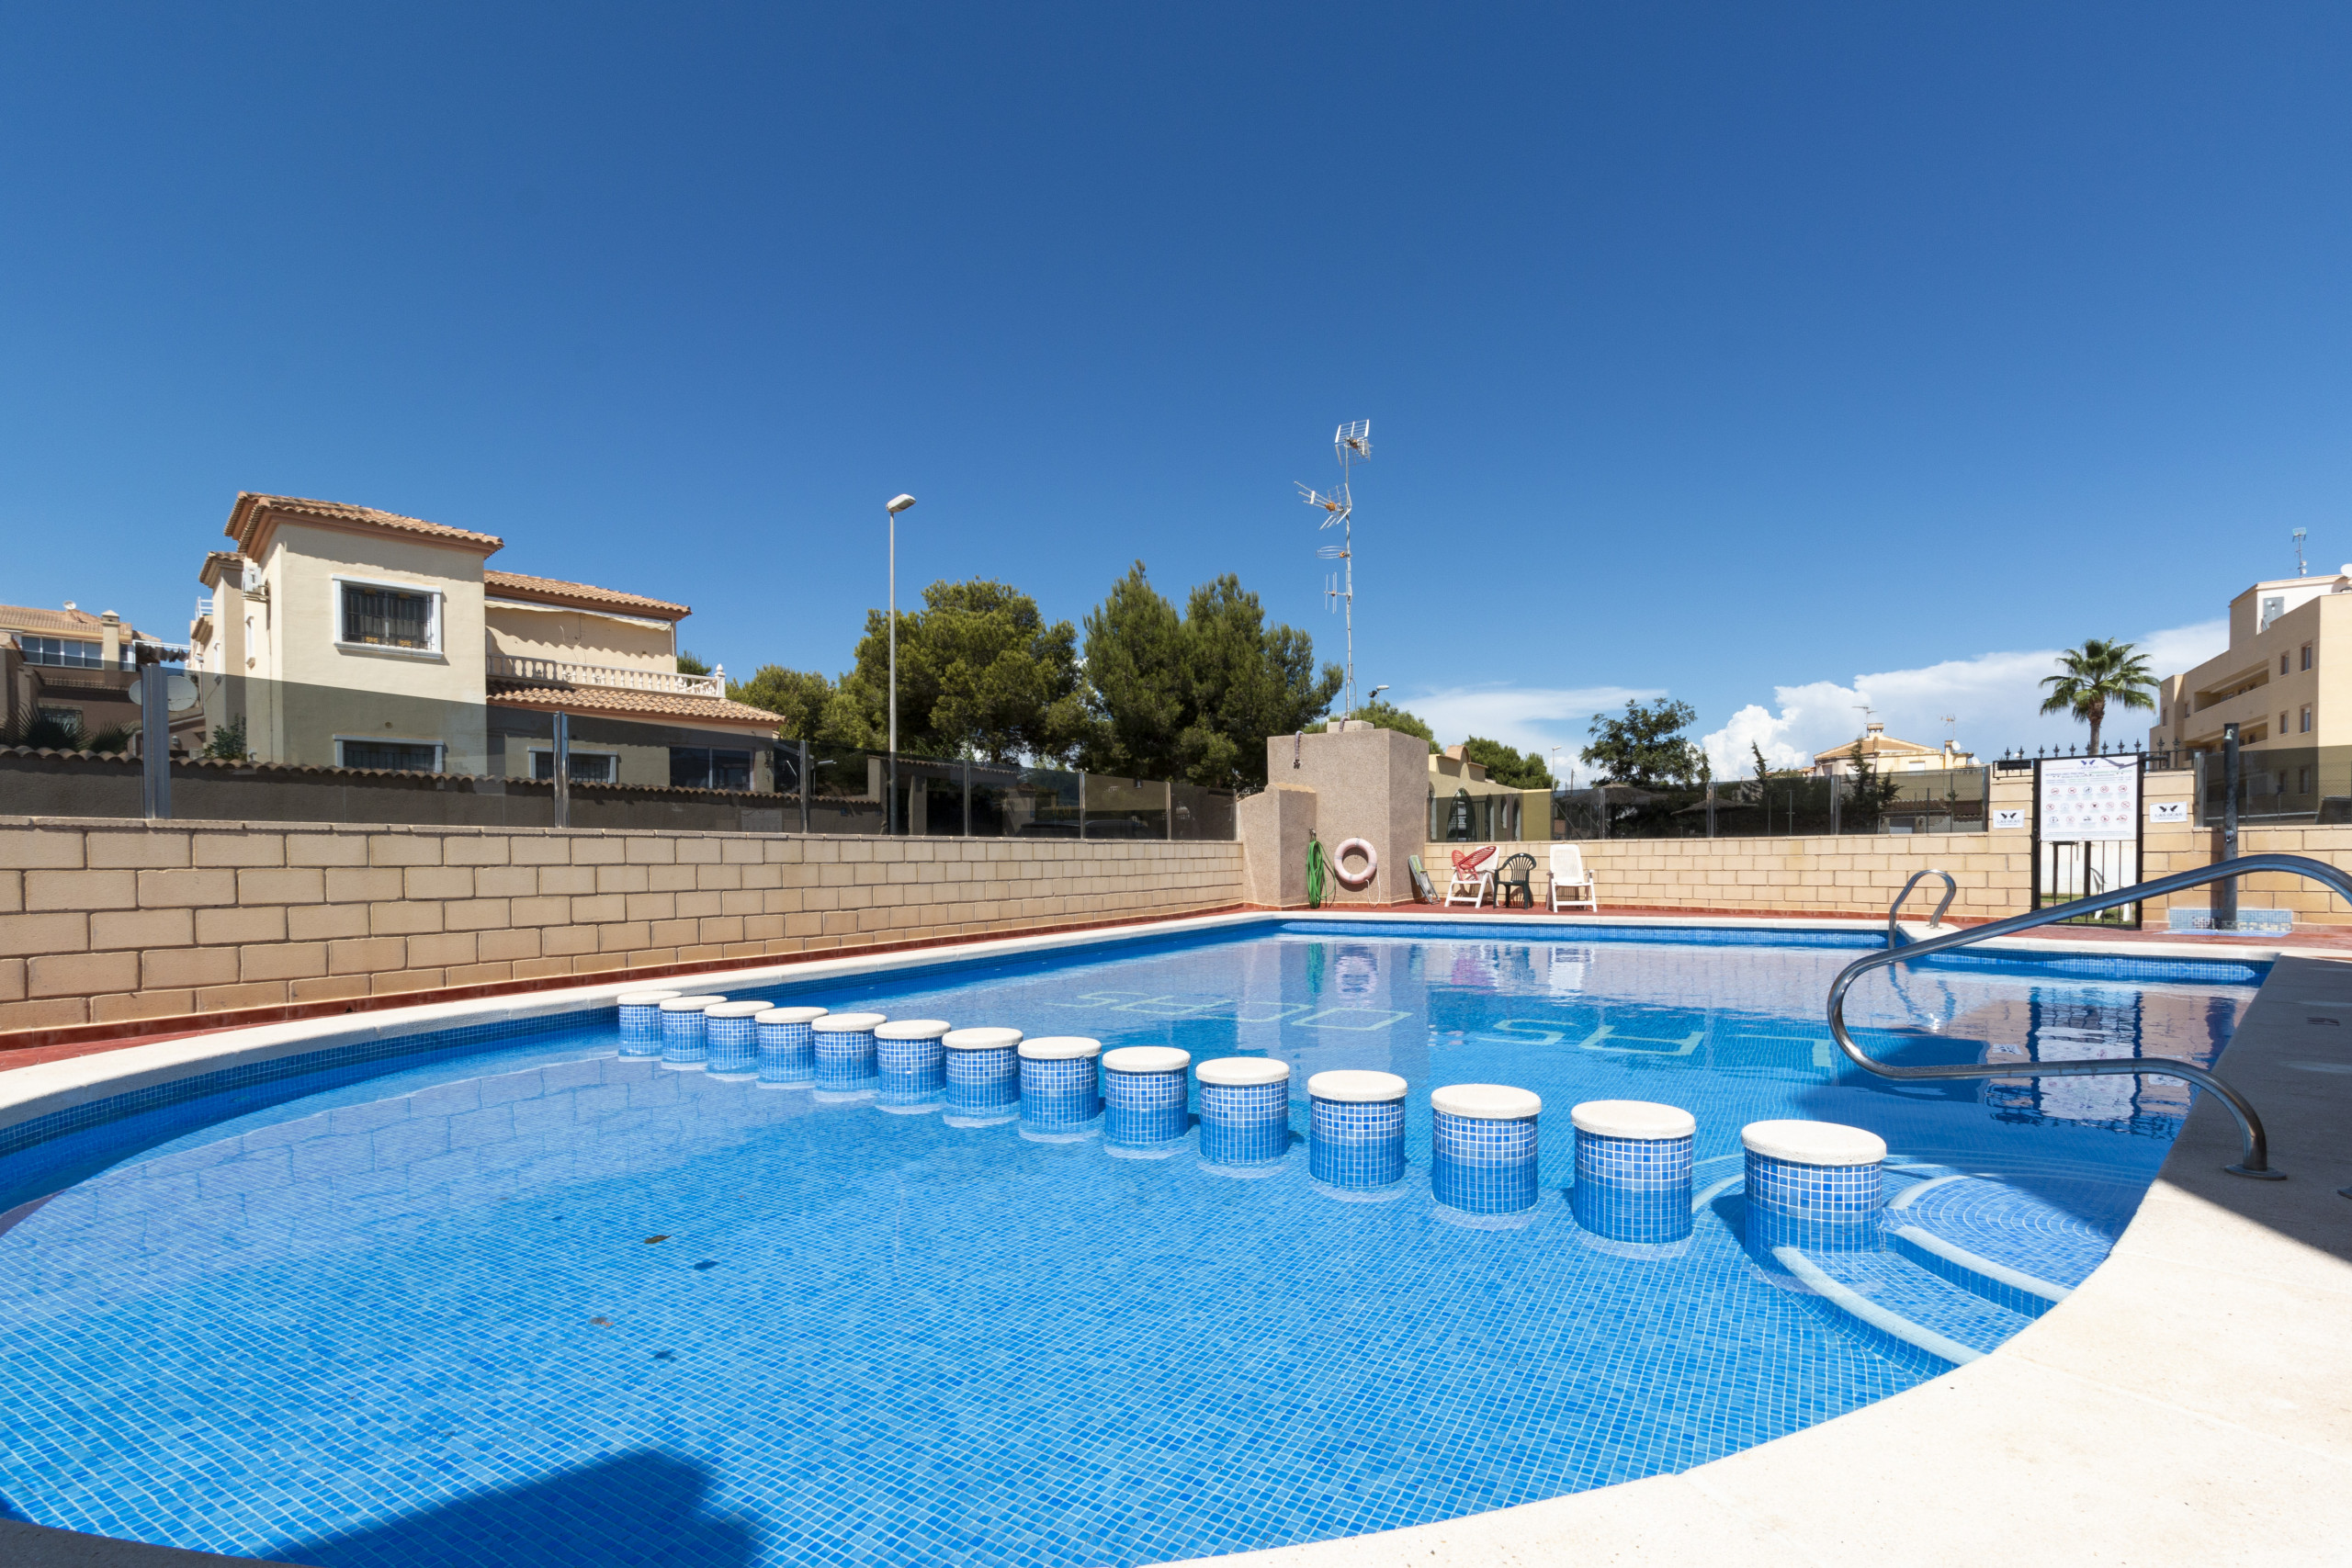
[268,1450,760,1568]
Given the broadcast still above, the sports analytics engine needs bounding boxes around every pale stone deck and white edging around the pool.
[0,909,2352,1568]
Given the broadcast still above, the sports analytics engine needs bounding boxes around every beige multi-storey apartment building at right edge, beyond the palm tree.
[2147,567,2352,752]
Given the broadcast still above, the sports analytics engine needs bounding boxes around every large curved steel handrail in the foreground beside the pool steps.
[1830,856,2352,1180]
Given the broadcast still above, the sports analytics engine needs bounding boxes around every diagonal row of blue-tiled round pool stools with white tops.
[618,992,1886,1244]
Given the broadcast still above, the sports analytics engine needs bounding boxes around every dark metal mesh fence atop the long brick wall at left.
[0,670,1238,841]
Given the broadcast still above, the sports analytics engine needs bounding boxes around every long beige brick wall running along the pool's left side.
[0,818,1242,1030]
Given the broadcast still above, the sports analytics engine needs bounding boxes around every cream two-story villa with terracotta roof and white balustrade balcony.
[188,493,776,790]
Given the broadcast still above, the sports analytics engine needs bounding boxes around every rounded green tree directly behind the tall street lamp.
[819,579,1084,761]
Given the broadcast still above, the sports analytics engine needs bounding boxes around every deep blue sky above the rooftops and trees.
[0,5,2352,771]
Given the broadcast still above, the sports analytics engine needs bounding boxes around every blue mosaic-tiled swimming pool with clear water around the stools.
[0,921,2260,1568]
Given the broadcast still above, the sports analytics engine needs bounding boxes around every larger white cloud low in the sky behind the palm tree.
[1701,621,2230,778]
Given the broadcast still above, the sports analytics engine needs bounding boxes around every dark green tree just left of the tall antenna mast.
[1080,562,1343,790]
